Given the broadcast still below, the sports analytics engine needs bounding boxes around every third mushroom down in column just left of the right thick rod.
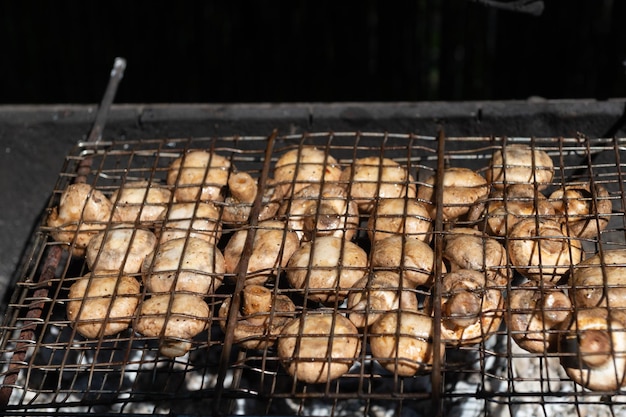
[370,235,436,288]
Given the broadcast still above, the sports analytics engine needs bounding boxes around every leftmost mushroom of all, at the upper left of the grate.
[47,183,116,255]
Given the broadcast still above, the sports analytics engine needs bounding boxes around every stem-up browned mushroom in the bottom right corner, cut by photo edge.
[559,307,626,391]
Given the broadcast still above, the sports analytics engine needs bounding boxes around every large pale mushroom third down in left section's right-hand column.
[141,237,225,295]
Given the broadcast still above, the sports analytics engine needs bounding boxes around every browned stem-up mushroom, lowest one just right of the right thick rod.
[426,269,504,346]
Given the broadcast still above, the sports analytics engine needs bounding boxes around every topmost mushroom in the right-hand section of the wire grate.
[485,144,554,190]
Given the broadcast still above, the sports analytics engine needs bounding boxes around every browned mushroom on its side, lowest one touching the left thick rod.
[218,285,296,349]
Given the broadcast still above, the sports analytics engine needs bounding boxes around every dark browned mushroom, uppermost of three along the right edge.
[550,183,613,238]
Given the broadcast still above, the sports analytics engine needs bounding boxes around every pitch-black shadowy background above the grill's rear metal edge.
[0,0,626,104]
